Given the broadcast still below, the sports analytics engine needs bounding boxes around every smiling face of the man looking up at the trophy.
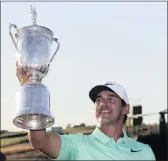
[95,91,123,125]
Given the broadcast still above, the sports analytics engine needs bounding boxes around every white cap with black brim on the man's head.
[89,82,129,104]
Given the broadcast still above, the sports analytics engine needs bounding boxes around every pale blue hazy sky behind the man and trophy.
[1,2,167,131]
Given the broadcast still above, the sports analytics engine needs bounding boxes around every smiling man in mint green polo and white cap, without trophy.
[17,62,155,160]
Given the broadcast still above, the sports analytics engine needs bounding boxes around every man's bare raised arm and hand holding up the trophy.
[16,63,61,158]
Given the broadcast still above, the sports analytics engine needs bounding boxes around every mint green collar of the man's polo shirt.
[91,127,127,144]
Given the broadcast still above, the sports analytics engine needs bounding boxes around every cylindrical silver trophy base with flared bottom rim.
[13,84,54,130]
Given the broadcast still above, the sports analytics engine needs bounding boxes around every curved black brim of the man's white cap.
[89,85,113,102]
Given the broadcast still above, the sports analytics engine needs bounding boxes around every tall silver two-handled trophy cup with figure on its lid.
[9,7,60,130]
